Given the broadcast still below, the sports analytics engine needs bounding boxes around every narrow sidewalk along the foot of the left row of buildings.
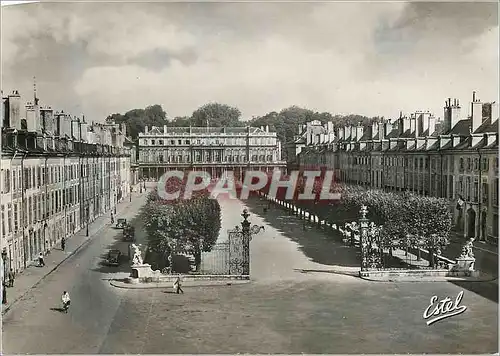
[2,189,144,315]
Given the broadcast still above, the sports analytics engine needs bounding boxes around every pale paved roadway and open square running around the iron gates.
[3,192,498,354]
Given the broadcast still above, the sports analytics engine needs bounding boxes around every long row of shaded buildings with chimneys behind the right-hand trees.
[298,93,499,244]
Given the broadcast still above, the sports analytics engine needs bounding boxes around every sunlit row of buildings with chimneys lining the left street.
[0,91,130,272]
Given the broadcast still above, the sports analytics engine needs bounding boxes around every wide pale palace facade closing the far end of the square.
[138,126,286,180]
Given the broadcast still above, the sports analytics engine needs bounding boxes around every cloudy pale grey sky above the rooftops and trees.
[1,2,499,122]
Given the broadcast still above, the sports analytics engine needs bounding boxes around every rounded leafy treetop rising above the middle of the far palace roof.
[191,103,243,127]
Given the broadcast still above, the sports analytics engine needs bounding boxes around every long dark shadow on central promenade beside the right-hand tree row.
[245,198,360,267]
